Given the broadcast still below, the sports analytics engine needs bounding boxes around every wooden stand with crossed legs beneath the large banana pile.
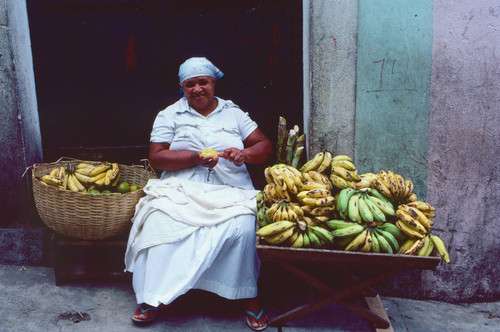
[257,243,441,331]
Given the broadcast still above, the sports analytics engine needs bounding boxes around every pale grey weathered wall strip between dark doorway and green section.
[309,0,357,156]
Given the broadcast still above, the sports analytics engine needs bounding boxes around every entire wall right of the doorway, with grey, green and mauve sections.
[309,0,500,301]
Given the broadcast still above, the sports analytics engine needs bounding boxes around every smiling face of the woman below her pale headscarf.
[182,76,215,112]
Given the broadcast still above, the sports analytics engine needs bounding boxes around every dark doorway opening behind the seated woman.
[27,0,303,186]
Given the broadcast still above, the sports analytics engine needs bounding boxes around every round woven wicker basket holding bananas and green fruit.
[32,159,156,240]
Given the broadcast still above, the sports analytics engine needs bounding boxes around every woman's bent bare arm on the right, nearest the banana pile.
[221,129,273,164]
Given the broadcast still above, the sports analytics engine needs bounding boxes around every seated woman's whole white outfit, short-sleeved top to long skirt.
[125,98,260,306]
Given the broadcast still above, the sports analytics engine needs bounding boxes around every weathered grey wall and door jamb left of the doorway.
[0,0,45,264]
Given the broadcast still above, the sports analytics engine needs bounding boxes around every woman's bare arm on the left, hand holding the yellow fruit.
[149,143,218,171]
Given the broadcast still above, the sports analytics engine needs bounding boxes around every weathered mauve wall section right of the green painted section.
[424,0,500,300]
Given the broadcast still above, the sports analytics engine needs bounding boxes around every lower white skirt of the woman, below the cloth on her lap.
[131,211,260,306]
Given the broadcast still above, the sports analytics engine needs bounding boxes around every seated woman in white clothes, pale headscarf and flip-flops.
[125,58,272,330]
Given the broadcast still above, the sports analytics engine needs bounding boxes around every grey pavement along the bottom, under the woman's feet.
[0,265,500,332]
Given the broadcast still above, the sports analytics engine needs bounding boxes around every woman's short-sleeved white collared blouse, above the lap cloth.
[150,97,257,189]
